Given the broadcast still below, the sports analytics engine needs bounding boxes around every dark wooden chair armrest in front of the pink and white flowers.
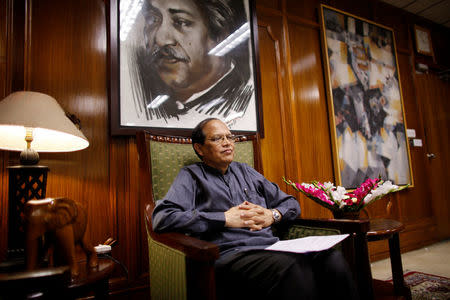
[289,218,370,234]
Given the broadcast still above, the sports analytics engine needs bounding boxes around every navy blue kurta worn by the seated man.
[153,162,300,258]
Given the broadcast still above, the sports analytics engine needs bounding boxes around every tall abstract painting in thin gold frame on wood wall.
[320,5,413,189]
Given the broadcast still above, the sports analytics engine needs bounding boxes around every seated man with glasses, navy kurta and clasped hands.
[153,118,358,300]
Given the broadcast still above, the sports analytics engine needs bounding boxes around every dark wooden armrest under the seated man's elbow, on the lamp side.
[150,231,219,261]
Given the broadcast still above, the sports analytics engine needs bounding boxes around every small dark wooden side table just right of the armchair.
[367,219,411,300]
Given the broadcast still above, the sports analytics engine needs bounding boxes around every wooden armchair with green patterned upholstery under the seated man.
[137,131,373,300]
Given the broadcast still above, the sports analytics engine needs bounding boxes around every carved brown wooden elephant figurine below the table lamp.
[24,198,98,276]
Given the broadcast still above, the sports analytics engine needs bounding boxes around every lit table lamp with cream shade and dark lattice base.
[0,91,89,257]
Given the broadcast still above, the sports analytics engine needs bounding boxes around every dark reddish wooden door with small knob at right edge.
[415,74,450,238]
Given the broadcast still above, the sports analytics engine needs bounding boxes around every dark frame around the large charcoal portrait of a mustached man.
[106,0,264,137]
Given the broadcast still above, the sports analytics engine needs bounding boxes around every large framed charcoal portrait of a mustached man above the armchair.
[109,0,263,135]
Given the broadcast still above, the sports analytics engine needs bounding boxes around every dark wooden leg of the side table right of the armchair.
[389,233,411,300]
